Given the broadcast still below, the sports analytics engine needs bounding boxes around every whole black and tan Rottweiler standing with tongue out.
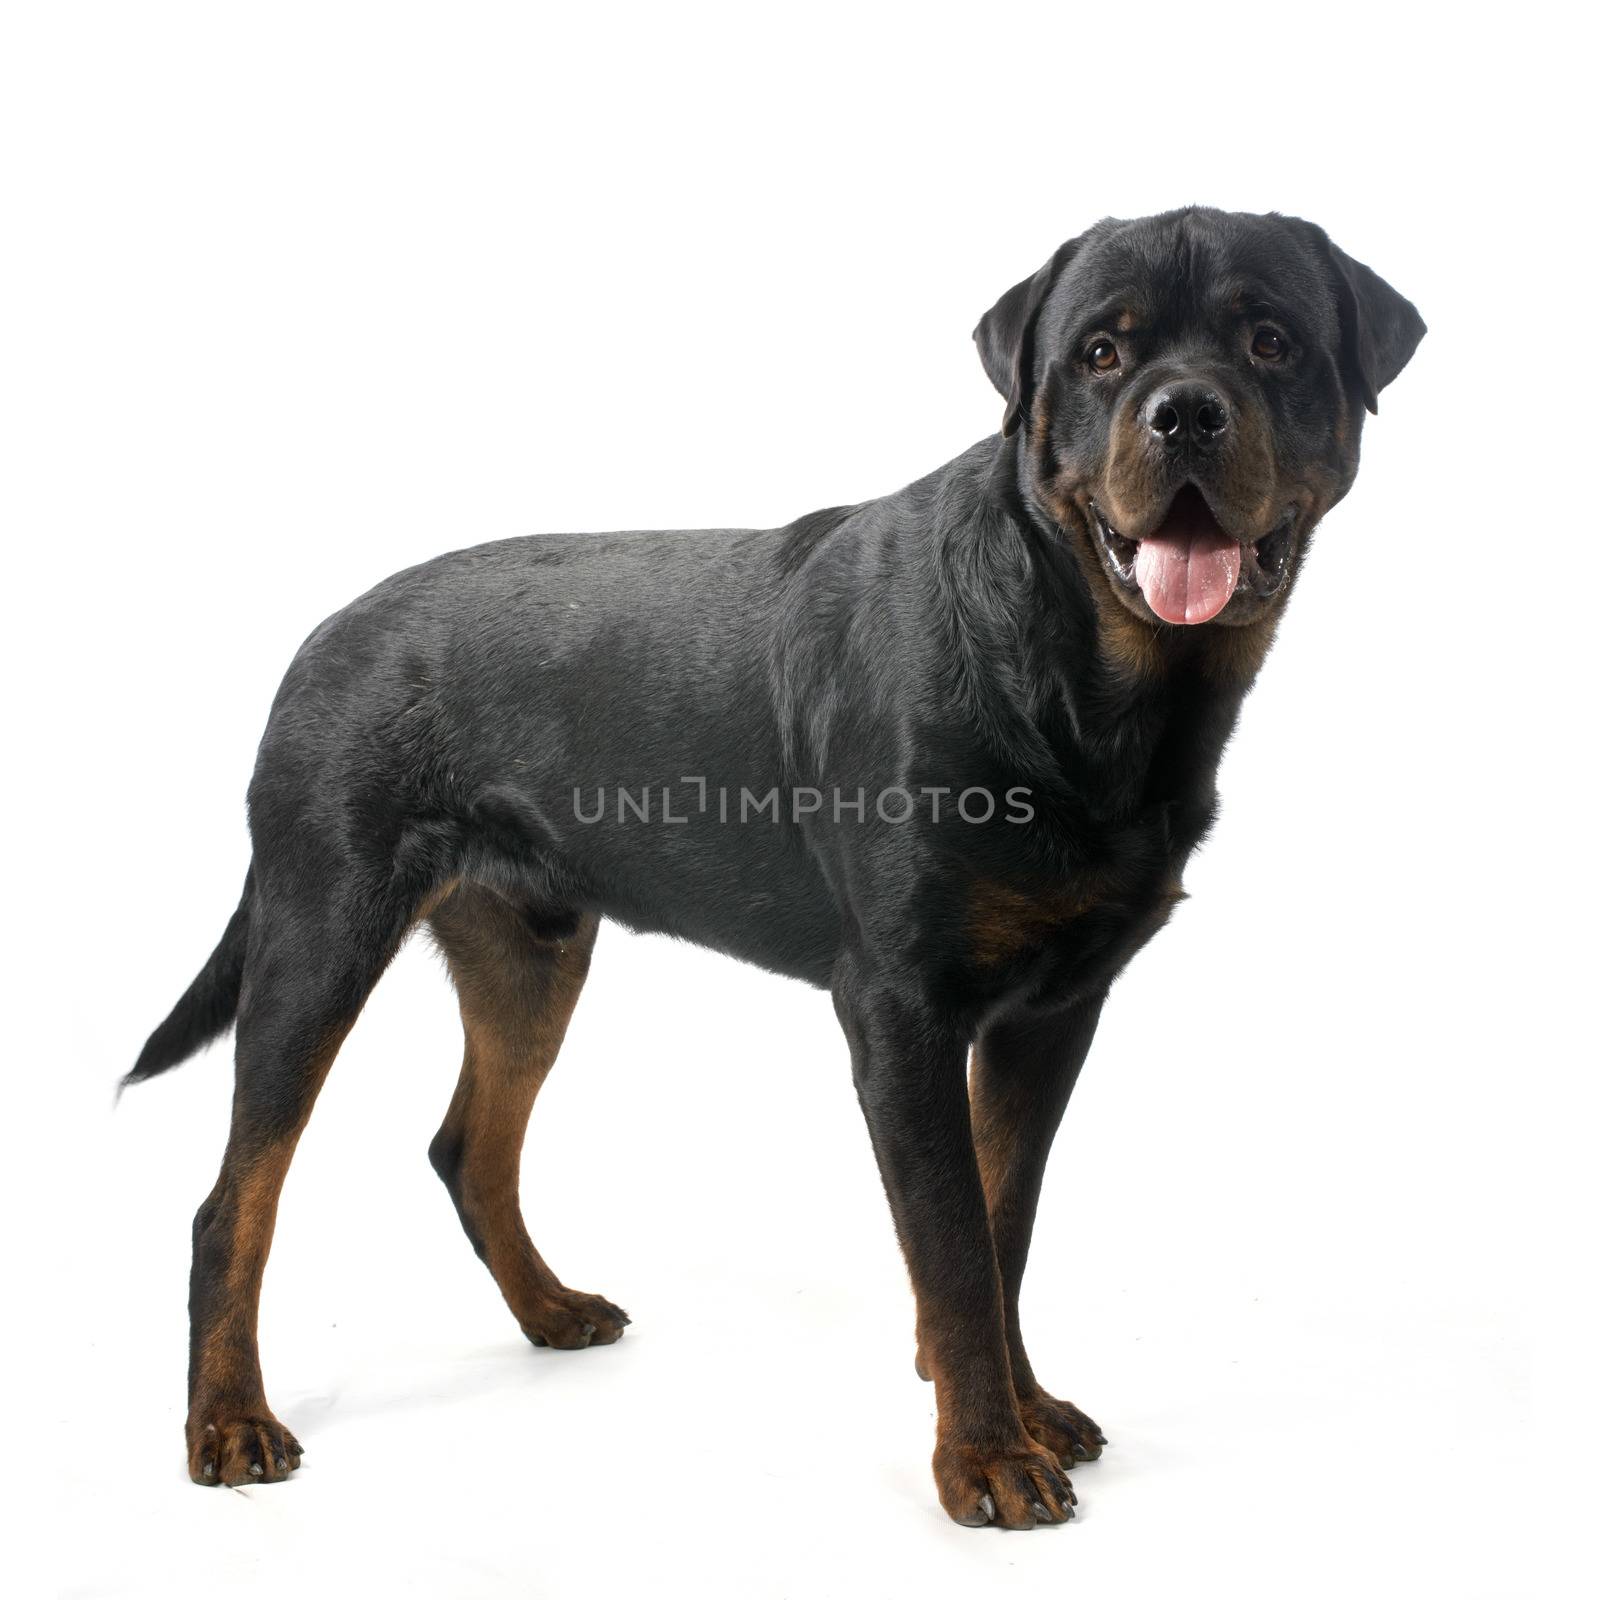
[130,210,1424,1528]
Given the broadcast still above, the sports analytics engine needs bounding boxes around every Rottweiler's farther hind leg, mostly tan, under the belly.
[427,886,629,1350]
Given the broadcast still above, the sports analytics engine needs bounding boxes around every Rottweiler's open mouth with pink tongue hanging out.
[1090,483,1294,626]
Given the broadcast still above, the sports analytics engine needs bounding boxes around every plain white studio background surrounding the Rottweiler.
[0,5,1597,1600]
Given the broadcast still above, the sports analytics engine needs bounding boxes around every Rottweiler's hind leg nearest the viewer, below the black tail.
[186,869,411,1485]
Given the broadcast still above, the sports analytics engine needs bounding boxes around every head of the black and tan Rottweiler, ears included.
[974,210,1424,627]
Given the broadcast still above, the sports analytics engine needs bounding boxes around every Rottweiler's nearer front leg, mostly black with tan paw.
[834,966,1074,1528]
